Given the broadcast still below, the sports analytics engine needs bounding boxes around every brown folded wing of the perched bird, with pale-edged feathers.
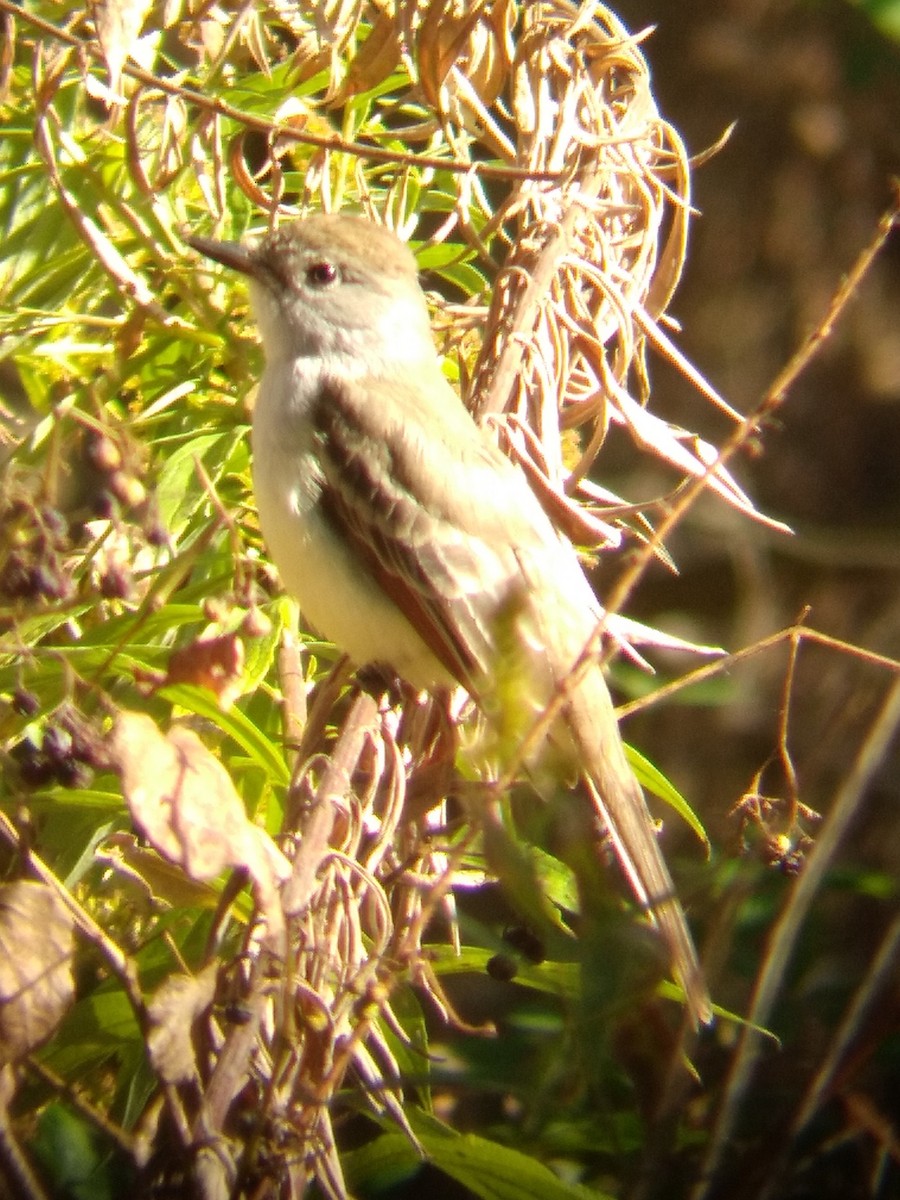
[313,370,553,690]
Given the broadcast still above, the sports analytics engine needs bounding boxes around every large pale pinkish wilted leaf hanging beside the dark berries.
[112,713,290,934]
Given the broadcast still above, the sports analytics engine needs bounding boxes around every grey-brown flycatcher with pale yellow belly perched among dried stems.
[191,215,710,1021]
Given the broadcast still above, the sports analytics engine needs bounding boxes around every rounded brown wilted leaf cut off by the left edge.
[0,880,74,1063]
